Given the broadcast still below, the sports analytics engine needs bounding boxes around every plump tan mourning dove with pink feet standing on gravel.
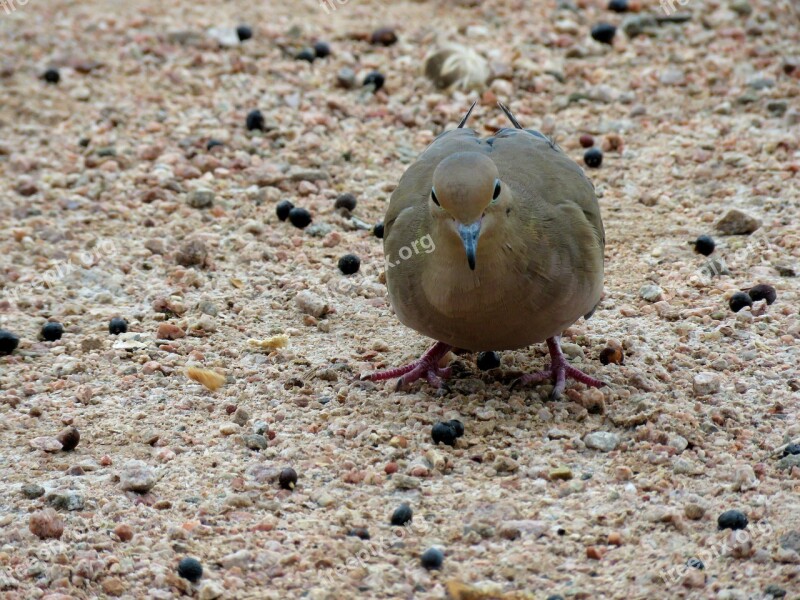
[362,104,605,397]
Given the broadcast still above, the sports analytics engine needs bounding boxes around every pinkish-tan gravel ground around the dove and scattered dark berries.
[0,0,800,600]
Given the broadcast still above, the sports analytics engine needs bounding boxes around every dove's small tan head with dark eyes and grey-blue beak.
[430,152,507,271]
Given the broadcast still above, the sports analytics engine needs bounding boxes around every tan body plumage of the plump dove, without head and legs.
[384,113,605,351]
